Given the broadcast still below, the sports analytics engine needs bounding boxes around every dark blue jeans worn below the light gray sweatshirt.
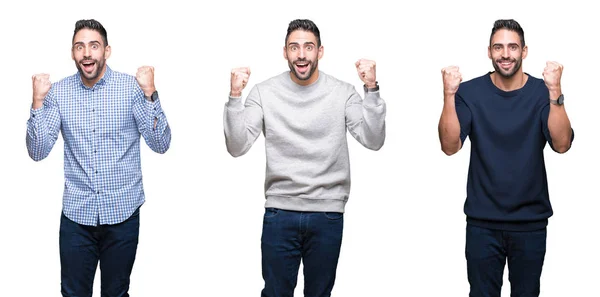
[261,208,344,297]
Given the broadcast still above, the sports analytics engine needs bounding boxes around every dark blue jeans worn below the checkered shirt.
[59,208,140,297]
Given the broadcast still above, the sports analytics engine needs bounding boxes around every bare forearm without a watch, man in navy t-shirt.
[438,95,462,156]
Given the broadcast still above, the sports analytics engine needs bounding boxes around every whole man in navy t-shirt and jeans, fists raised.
[439,20,574,297]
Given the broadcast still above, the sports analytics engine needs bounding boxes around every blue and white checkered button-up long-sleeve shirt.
[26,66,171,226]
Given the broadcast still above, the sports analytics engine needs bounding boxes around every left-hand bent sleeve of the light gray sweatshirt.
[223,86,263,157]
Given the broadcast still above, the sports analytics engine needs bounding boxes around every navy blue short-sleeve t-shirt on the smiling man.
[455,72,575,231]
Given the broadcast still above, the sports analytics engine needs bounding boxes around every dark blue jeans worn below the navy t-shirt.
[465,224,546,297]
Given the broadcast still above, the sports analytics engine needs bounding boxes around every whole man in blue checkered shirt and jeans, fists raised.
[26,19,171,297]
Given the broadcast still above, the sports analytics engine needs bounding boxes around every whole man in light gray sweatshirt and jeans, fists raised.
[224,20,386,297]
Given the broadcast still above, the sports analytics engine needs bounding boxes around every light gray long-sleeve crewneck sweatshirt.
[223,71,386,212]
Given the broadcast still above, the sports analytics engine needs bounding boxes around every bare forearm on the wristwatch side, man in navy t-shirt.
[548,90,573,153]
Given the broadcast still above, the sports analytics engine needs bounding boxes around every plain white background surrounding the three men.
[0,0,600,297]
